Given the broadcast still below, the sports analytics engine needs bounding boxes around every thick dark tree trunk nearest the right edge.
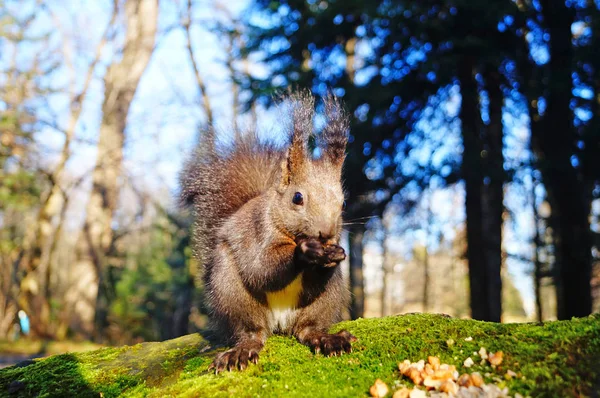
[536,0,592,319]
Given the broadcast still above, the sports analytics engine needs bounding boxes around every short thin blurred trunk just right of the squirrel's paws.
[348,225,365,319]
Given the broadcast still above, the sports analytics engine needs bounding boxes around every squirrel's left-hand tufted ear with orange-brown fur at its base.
[281,93,314,189]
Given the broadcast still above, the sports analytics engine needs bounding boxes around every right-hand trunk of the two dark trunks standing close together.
[481,65,505,322]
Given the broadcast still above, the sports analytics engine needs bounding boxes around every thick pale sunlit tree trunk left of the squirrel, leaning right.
[70,0,158,337]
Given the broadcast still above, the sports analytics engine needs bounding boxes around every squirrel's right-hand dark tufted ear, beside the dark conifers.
[322,94,350,167]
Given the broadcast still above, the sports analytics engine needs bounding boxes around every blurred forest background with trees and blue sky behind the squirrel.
[0,0,600,344]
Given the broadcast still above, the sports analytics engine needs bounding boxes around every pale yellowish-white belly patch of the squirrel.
[267,273,302,331]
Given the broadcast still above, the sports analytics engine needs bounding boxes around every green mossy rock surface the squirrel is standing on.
[0,314,600,397]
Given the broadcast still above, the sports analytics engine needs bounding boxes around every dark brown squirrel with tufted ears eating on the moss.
[181,93,356,373]
